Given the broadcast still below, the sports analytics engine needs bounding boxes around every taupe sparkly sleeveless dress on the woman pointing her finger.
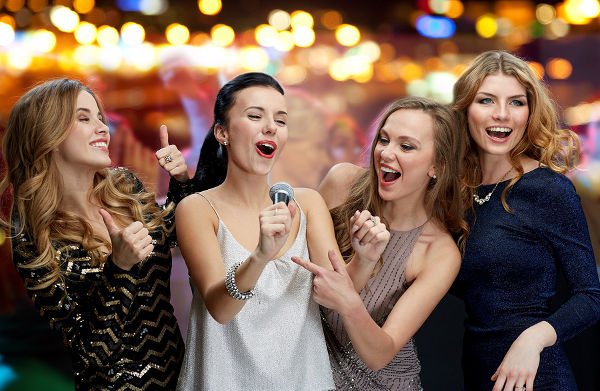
[321,225,424,391]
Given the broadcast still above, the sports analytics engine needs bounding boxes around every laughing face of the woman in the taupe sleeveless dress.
[373,109,436,201]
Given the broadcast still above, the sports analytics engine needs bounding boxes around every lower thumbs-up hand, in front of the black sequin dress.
[99,209,154,270]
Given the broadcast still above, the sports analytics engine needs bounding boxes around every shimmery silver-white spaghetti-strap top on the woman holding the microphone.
[177,196,335,391]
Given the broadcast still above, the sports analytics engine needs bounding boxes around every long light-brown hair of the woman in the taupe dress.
[331,97,468,273]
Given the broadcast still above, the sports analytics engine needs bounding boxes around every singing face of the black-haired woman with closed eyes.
[215,86,288,175]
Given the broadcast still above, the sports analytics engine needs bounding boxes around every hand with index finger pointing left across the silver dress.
[292,250,362,314]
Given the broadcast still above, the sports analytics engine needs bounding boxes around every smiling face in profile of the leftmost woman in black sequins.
[54,90,111,171]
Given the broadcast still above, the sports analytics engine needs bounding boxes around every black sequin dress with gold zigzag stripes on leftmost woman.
[12,174,195,390]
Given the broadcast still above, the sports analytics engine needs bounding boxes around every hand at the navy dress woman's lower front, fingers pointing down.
[491,321,557,391]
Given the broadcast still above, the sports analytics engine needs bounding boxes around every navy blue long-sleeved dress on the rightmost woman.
[453,168,600,391]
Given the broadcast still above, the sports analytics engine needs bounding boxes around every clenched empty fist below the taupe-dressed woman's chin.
[350,210,390,262]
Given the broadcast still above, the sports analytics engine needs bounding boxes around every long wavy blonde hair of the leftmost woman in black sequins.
[0,79,172,289]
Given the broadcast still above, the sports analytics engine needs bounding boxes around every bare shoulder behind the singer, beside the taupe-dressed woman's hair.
[317,163,366,209]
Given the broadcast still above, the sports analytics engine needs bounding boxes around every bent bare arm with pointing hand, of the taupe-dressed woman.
[294,234,460,370]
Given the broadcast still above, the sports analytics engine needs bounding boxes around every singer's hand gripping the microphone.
[254,202,297,262]
